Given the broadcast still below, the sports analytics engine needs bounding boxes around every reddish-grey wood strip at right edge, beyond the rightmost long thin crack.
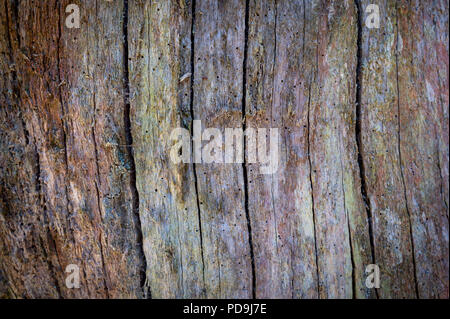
[396,1,449,298]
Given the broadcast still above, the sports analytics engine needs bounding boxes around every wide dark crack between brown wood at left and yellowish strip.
[122,0,152,299]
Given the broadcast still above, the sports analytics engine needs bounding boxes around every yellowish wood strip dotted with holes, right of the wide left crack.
[128,1,204,298]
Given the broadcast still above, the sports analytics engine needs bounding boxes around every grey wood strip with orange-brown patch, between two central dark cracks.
[192,0,253,298]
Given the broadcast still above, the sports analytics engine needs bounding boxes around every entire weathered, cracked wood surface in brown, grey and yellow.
[0,0,449,298]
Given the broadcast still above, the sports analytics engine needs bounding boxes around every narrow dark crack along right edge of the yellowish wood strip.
[189,0,208,298]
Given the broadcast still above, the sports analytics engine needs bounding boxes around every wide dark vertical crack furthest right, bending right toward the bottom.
[355,0,378,299]
